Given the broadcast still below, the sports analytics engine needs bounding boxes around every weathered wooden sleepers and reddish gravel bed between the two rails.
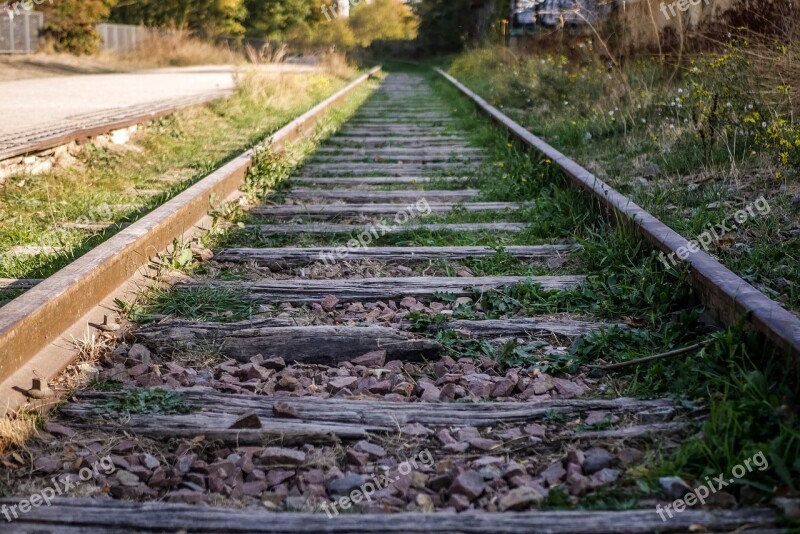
[0,74,782,533]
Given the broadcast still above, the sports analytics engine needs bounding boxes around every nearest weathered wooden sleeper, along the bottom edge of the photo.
[0,498,785,534]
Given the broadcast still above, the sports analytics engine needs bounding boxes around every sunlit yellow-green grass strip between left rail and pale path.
[0,71,360,284]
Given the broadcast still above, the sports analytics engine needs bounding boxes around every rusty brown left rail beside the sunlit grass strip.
[0,67,380,409]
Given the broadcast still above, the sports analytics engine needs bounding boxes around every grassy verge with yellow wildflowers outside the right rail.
[450,37,800,316]
